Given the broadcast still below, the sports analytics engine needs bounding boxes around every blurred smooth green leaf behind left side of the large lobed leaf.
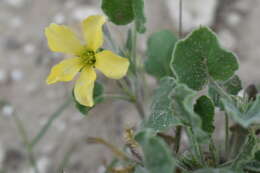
[145,30,177,79]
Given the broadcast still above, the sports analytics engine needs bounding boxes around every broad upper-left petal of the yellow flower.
[45,24,84,55]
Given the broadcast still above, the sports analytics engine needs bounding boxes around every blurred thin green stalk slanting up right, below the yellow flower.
[31,98,72,148]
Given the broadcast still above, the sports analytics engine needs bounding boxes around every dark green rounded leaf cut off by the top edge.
[102,0,134,25]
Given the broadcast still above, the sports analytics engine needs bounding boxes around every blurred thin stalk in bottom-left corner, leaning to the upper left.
[13,114,39,173]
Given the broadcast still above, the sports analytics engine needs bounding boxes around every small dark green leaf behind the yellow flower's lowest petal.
[72,82,104,116]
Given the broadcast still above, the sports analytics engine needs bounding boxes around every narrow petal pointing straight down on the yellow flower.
[74,67,96,107]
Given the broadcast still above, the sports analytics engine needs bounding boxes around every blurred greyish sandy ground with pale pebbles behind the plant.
[0,0,260,173]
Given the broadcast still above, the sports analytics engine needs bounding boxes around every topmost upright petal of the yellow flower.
[82,15,106,51]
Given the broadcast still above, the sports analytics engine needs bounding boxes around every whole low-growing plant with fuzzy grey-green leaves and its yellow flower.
[9,0,260,173]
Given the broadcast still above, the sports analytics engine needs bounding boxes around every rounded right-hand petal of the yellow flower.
[95,50,129,79]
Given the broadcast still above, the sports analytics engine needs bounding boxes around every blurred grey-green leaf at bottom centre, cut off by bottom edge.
[135,129,175,173]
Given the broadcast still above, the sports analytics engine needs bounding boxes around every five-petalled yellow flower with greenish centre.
[45,15,129,107]
